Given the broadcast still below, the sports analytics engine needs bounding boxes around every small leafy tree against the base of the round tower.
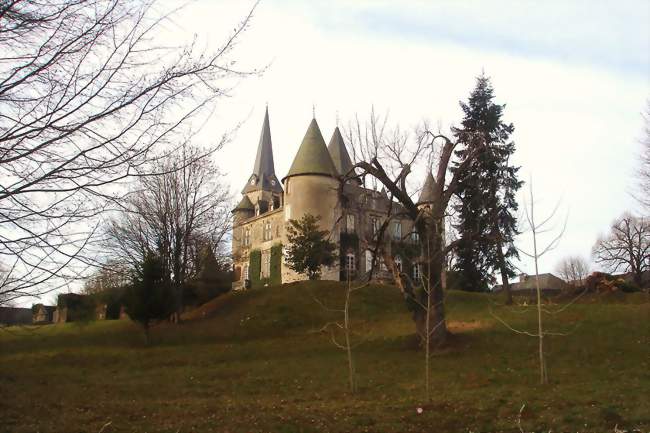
[286,214,337,280]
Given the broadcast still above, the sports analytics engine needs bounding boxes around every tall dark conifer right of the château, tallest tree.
[453,74,523,302]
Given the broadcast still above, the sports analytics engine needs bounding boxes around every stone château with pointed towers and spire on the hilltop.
[232,108,433,289]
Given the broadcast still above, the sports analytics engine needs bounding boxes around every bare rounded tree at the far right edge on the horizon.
[592,213,650,286]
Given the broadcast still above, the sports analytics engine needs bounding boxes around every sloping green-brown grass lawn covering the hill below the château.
[0,282,650,433]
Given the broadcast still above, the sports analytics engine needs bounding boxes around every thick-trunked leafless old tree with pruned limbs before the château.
[343,110,477,347]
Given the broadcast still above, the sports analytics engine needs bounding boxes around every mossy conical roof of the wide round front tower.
[283,119,338,180]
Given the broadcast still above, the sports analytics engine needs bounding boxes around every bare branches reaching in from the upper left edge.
[0,0,252,299]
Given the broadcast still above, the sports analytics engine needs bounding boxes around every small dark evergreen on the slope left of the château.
[125,252,174,344]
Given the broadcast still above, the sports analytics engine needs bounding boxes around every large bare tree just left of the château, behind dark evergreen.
[106,146,231,316]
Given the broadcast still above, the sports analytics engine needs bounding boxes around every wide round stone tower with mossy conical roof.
[282,119,341,282]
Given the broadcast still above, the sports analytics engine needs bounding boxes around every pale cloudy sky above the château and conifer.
[172,0,650,272]
